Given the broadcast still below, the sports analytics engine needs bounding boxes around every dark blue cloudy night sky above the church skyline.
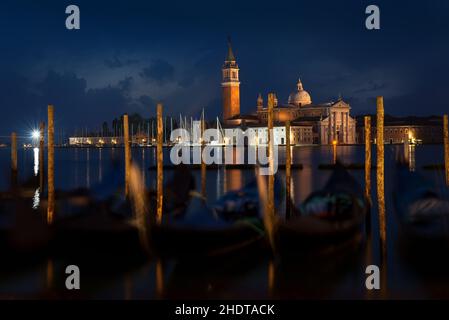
[0,0,449,136]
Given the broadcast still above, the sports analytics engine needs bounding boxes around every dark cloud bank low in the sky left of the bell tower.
[0,70,152,135]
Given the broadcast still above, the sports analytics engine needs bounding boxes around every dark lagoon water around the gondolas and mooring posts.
[0,145,449,299]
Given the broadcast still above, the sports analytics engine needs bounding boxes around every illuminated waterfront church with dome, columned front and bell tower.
[221,42,356,144]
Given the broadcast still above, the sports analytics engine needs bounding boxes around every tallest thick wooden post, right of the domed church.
[376,97,387,253]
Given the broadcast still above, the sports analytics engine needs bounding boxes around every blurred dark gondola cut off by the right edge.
[393,163,449,260]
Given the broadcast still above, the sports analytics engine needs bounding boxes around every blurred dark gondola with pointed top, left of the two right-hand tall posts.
[274,164,370,258]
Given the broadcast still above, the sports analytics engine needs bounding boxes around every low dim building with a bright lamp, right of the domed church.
[357,115,443,144]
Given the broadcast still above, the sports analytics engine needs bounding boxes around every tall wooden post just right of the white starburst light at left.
[47,105,55,224]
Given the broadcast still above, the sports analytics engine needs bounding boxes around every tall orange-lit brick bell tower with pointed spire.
[221,38,240,123]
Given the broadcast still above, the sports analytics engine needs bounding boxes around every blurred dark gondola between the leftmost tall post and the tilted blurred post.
[48,167,147,265]
